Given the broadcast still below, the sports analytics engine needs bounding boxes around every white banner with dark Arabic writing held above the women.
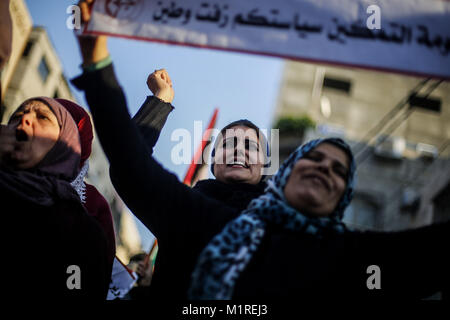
[86,0,450,79]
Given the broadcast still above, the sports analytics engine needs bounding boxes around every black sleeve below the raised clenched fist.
[133,96,174,153]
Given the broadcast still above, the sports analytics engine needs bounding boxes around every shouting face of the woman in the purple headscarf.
[9,101,60,169]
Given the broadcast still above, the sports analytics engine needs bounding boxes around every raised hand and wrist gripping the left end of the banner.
[77,0,109,66]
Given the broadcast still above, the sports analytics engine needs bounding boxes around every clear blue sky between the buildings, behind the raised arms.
[26,0,283,179]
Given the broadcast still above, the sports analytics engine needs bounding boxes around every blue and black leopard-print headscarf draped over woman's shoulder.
[188,138,356,300]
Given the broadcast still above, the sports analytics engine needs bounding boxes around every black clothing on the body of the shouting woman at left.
[0,182,111,301]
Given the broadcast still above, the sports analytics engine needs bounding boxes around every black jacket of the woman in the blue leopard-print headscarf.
[75,66,450,300]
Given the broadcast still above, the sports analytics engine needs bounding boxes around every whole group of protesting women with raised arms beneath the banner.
[0,1,450,300]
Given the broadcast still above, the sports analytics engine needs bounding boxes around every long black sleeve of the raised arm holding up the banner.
[72,65,238,244]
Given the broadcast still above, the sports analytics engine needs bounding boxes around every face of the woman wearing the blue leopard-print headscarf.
[284,142,349,217]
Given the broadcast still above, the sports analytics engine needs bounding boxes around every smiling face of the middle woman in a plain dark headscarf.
[214,126,264,184]
